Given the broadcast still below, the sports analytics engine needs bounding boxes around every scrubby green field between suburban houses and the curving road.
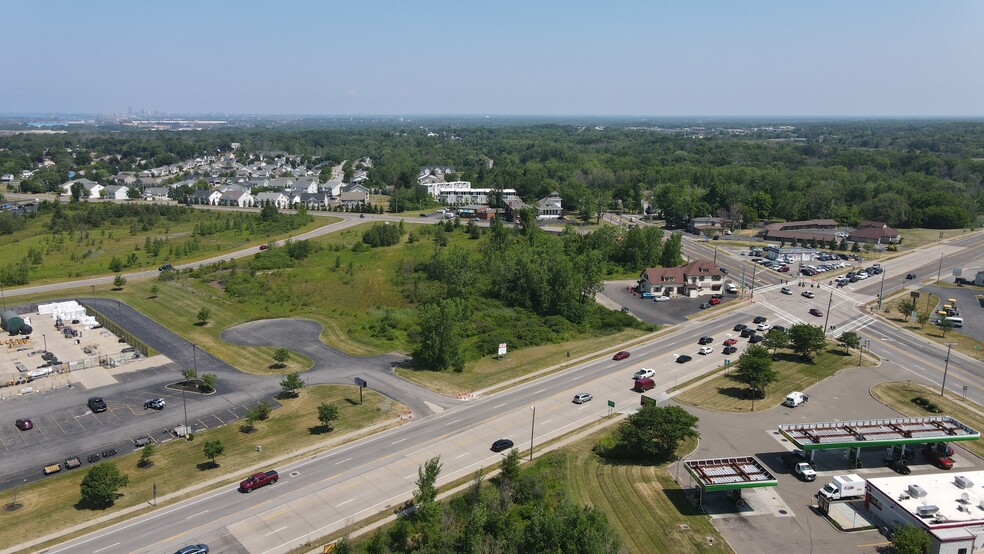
[0,210,339,283]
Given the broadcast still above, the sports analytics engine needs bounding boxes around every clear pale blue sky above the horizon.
[0,0,984,117]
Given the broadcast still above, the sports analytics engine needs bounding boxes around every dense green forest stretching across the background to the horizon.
[0,120,984,228]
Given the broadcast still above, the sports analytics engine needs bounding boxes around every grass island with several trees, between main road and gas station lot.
[671,347,870,412]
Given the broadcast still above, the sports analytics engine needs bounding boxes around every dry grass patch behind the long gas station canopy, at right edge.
[871,381,984,459]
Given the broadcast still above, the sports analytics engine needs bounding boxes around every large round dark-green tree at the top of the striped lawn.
[616,404,699,460]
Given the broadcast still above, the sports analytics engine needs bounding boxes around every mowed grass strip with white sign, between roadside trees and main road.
[396,329,646,395]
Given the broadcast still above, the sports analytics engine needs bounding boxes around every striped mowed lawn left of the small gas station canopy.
[563,429,733,554]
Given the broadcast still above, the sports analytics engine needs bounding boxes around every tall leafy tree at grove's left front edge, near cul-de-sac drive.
[413,298,466,371]
